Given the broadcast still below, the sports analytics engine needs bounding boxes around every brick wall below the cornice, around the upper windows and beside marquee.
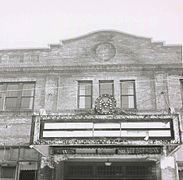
[0,71,182,145]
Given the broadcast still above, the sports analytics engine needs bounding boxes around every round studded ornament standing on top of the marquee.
[95,94,116,115]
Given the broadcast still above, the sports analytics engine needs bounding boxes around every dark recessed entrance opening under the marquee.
[64,162,157,180]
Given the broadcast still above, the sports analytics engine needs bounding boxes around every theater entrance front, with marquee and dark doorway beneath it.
[33,115,179,180]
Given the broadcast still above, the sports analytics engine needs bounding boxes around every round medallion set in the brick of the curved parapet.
[95,43,116,61]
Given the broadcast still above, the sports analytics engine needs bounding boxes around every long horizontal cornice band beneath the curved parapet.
[0,64,183,73]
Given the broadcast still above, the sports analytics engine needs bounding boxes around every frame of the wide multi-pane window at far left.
[0,81,36,112]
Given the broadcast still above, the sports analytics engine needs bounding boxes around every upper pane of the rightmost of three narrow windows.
[121,81,134,95]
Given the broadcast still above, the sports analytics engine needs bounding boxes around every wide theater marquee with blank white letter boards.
[31,115,180,147]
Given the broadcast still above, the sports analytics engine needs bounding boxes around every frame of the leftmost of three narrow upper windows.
[77,80,93,109]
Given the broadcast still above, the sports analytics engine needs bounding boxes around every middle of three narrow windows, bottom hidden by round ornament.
[99,80,114,96]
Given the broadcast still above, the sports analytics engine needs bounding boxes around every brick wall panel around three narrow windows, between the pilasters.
[58,72,159,111]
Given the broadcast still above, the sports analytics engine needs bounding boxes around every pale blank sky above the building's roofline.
[0,0,183,49]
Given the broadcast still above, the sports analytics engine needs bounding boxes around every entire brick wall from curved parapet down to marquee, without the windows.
[0,32,182,148]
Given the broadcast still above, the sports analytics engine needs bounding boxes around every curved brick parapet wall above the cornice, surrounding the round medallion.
[0,31,182,67]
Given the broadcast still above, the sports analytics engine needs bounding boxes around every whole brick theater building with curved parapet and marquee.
[0,31,183,180]
